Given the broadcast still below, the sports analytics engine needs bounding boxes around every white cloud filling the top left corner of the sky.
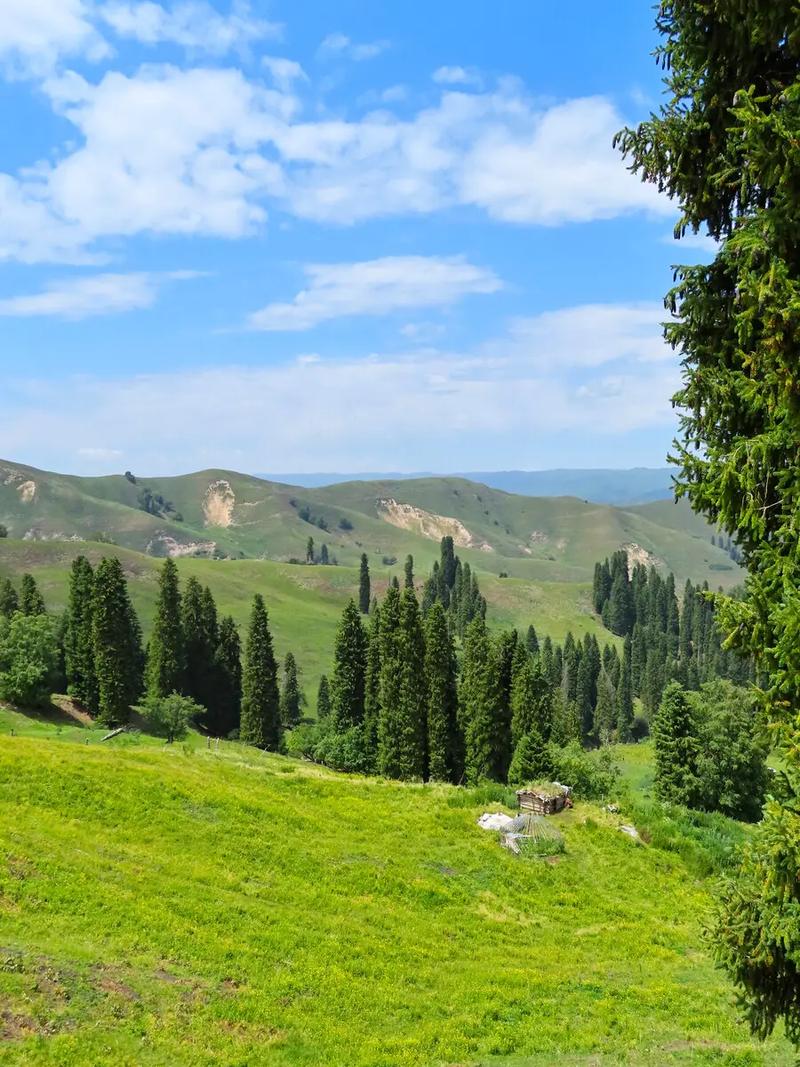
[0,0,110,77]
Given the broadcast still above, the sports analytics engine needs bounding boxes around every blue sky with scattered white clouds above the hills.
[0,0,707,474]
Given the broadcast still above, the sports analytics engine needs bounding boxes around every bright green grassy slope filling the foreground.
[0,710,793,1067]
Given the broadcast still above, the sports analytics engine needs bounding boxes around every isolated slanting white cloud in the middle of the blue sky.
[249,256,502,330]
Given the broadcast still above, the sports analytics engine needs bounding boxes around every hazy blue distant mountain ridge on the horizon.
[256,467,673,507]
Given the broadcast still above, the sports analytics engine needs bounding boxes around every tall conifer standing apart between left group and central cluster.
[239,593,281,750]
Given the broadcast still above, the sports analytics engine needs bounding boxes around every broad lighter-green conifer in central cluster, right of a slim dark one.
[459,616,505,785]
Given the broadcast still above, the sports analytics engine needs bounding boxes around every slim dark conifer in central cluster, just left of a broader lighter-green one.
[425,604,461,782]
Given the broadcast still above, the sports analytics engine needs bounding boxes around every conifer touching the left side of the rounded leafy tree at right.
[651,682,699,805]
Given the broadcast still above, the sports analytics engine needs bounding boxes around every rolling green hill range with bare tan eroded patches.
[0,462,741,587]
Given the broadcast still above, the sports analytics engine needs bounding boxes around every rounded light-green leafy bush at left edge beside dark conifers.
[0,612,59,707]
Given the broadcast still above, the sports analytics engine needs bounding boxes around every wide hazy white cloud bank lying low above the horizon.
[0,298,679,473]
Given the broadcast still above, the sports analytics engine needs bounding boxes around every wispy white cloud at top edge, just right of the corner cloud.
[98,0,282,55]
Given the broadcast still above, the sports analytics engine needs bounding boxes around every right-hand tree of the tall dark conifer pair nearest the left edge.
[92,556,142,726]
